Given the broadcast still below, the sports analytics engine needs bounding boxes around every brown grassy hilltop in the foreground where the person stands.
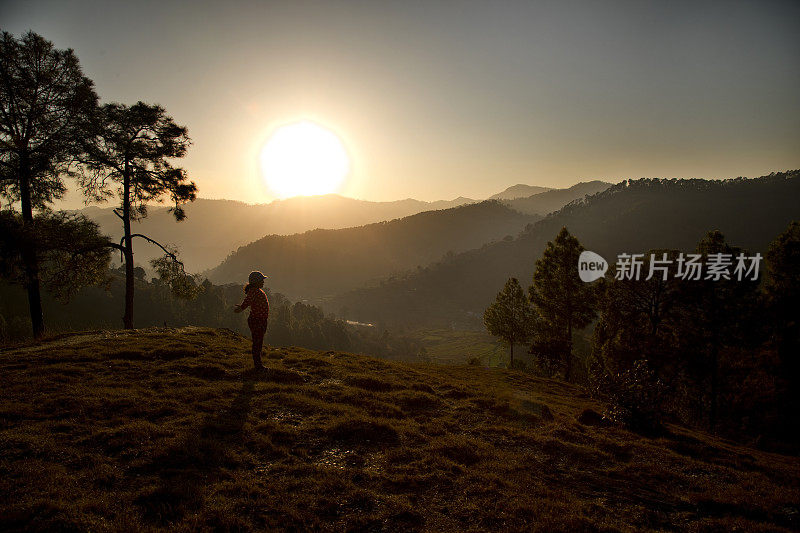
[0,328,800,531]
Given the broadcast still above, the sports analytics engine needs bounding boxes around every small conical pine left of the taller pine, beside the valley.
[483,278,534,368]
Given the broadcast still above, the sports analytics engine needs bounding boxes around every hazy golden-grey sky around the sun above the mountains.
[0,0,800,206]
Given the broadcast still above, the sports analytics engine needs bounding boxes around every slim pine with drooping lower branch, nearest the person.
[81,102,197,329]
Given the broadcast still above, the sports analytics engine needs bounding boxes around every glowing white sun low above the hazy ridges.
[260,120,350,198]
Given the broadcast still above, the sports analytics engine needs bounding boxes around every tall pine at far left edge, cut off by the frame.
[0,32,97,337]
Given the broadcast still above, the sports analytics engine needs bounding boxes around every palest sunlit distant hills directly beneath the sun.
[82,194,474,272]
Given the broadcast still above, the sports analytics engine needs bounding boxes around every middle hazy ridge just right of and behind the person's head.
[208,201,539,298]
